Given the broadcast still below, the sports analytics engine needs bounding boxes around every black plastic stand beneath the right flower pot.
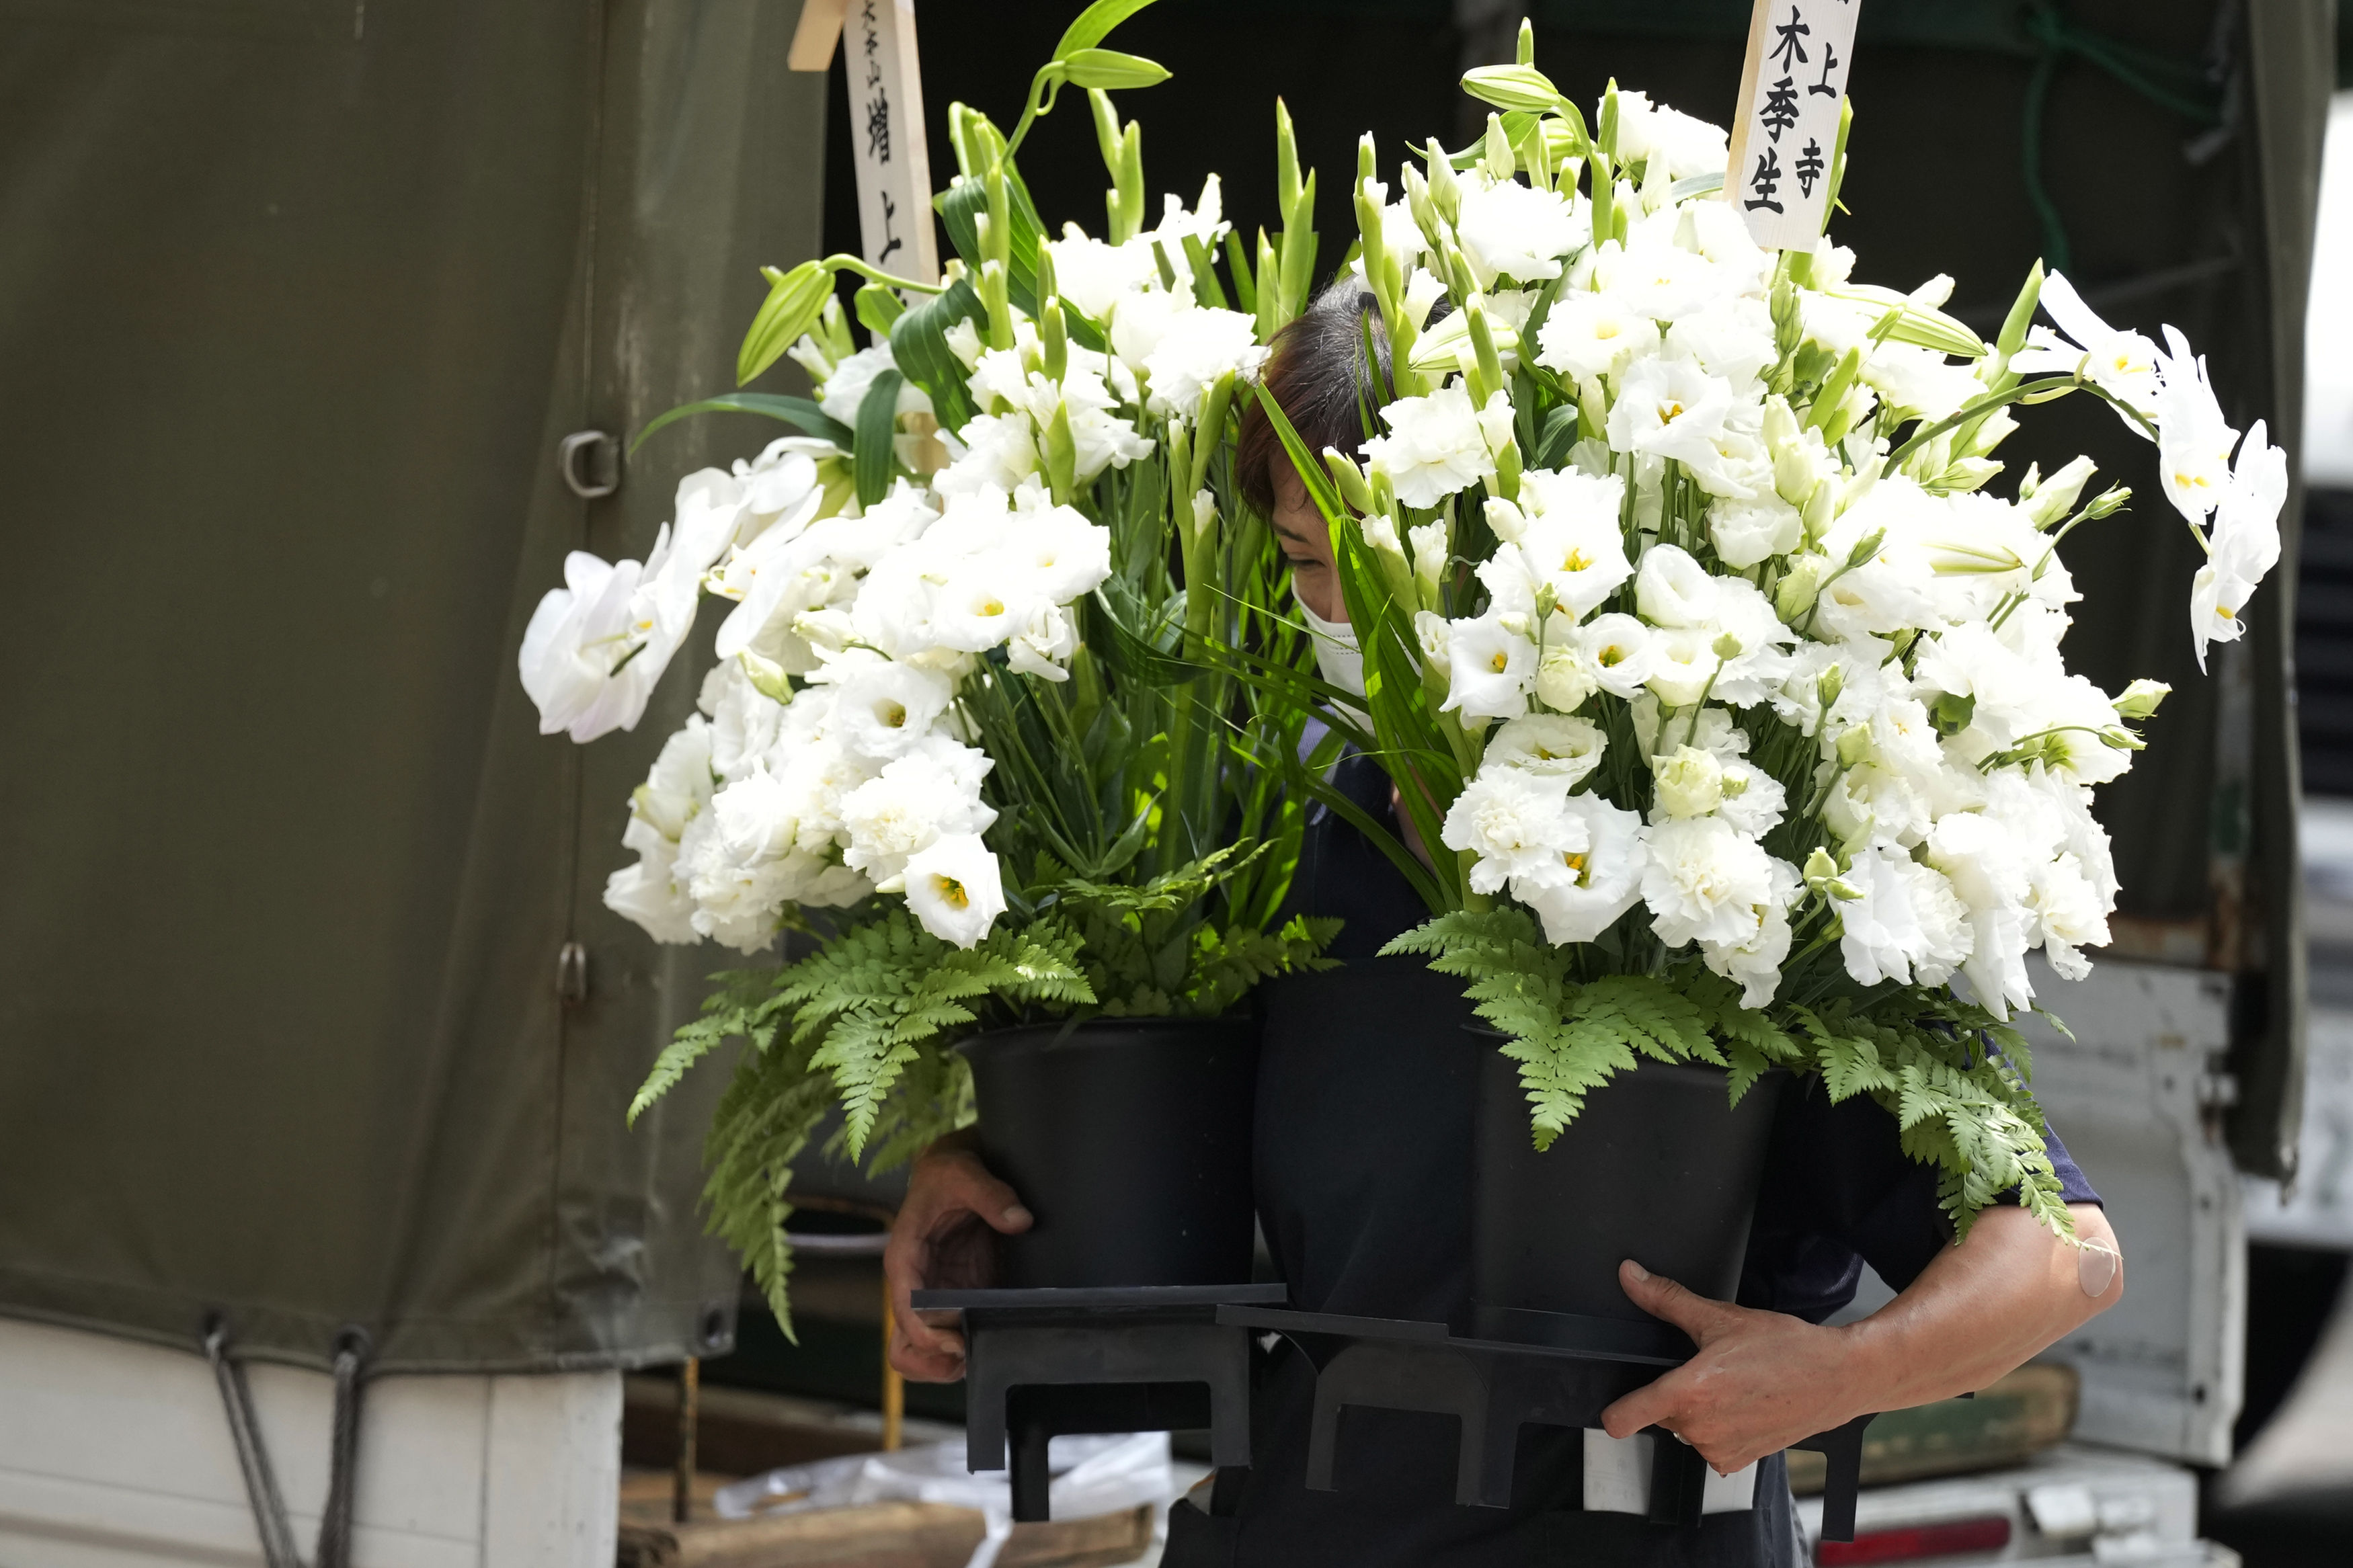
[1217,1305,1871,1540]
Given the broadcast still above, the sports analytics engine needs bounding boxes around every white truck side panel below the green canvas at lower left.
[0,1319,621,1568]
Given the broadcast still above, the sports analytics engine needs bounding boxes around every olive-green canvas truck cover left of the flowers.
[0,0,824,1370]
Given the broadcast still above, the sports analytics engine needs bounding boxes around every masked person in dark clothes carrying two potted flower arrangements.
[885,285,2125,1568]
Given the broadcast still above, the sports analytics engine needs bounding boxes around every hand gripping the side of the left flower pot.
[883,1130,1031,1383]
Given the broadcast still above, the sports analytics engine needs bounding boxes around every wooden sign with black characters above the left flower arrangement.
[786,0,939,282]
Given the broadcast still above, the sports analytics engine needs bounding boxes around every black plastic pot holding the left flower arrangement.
[960,1018,1259,1288]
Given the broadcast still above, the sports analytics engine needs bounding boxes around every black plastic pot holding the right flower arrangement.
[1471,1030,1788,1356]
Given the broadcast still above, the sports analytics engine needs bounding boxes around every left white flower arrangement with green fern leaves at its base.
[522,0,1337,1317]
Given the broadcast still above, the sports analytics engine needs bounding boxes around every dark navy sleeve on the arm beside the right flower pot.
[1739,1077,2099,1323]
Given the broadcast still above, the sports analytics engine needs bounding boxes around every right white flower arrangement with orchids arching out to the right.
[1271,42,2287,1229]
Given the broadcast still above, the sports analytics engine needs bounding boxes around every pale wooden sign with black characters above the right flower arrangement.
[1725,0,1864,249]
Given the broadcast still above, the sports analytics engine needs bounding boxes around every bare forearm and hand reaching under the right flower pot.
[1603,1204,2125,1474]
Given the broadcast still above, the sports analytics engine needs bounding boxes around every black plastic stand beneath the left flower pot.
[913,1284,1285,1524]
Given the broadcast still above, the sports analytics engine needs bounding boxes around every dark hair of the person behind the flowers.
[1233,273,1449,518]
